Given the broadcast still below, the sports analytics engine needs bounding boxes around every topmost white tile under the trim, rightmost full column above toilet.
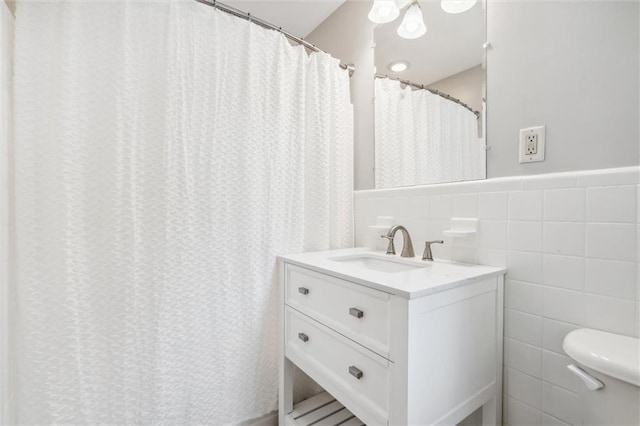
[587,186,637,223]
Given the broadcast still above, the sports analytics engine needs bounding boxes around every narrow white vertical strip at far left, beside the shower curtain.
[0,2,13,424]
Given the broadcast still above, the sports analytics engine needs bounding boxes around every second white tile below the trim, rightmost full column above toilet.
[586,223,636,262]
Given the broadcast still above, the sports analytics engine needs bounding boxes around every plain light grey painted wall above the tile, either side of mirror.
[309,0,640,189]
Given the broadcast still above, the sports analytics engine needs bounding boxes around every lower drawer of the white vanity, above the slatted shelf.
[285,307,389,425]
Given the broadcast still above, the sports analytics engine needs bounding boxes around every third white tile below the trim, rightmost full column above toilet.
[585,258,637,299]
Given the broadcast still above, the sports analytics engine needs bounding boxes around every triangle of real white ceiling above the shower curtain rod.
[222,0,345,38]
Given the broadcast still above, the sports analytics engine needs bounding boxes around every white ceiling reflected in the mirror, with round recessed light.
[375,0,485,85]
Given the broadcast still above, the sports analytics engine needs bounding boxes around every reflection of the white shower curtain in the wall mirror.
[375,78,486,188]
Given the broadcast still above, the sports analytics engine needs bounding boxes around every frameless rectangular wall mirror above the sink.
[374,0,486,189]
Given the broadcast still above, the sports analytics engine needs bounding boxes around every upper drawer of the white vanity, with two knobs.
[285,264,389,358]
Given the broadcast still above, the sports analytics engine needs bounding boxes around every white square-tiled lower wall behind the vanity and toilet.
[355,167,640,426]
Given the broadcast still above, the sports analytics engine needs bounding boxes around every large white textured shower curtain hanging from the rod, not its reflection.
[12,0,353,425]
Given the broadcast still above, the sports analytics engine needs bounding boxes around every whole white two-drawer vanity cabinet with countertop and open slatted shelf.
[279,249,504,425]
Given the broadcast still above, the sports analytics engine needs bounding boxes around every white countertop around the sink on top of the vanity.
[278,248,506,299]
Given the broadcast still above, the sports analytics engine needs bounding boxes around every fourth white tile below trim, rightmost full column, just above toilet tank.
[585,294,636,336]
